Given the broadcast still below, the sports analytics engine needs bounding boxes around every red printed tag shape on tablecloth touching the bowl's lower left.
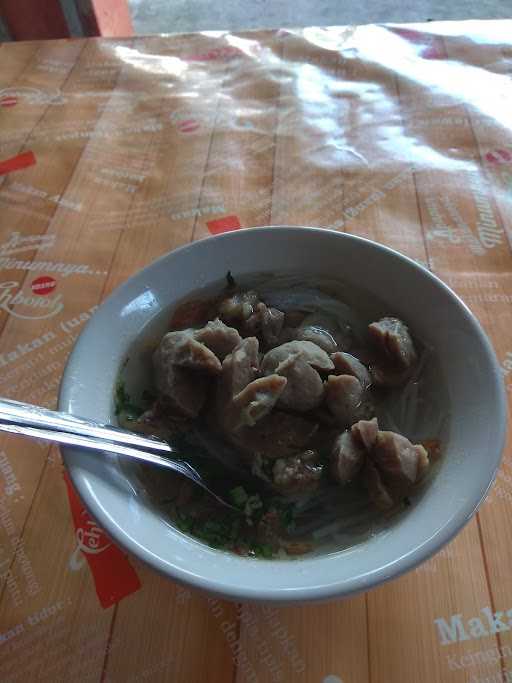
[64,472,141,608]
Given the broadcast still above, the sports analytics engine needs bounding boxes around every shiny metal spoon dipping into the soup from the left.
[0,398,240,512]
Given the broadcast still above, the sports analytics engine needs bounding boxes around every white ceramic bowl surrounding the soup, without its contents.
[59,227,506,602]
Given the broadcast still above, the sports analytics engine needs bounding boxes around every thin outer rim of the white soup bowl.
[58,225,508,604]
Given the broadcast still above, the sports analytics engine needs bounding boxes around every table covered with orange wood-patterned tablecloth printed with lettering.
[0,20,512,683]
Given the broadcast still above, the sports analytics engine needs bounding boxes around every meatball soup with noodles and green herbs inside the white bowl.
[116,273,446,559]
